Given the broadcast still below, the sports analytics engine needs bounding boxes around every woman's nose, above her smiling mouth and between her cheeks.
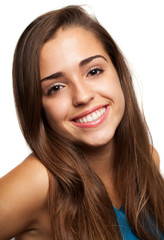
[72,79,95,107]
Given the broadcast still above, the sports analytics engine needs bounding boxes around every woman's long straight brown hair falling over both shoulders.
[13,6,164,240]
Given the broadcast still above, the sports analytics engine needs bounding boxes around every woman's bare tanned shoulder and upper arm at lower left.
[0,155,49,239]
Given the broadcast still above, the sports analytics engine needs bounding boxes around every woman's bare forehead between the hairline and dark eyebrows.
[39,27,110,78]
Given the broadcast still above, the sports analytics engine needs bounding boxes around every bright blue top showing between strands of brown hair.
[114,207,164,240]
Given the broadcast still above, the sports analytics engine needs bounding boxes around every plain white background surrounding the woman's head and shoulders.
[0,0,164,177]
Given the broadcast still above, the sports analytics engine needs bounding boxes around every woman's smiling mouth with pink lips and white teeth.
[72,105,109,128]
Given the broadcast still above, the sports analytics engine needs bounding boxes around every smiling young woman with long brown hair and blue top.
[0,6,164,240]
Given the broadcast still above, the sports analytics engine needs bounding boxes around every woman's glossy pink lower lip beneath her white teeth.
[71,105,109,128]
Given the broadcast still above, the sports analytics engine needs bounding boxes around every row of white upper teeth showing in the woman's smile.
[76,107,106,123]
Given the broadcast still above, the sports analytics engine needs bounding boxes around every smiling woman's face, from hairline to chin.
[40,27,125,147]
